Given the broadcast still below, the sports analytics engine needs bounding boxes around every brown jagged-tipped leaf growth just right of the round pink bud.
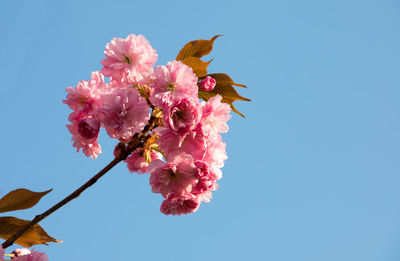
[199,73,251,118]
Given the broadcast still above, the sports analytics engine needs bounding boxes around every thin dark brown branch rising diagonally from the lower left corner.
[0,117,156,247]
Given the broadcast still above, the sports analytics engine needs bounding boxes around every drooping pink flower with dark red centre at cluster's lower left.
[66,113,101,159]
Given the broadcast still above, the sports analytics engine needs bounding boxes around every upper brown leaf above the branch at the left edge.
[0,189,52,213]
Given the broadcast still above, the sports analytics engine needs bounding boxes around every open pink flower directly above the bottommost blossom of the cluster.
[150,154,196,198]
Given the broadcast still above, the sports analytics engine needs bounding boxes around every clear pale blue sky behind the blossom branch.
[0,0,400,261]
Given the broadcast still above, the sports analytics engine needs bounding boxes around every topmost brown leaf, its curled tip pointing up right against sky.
[176,35,222,61]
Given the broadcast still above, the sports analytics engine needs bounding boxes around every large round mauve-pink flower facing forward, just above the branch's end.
[99,88,150,141]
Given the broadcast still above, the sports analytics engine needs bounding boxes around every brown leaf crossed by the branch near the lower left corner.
[0,217,62,247]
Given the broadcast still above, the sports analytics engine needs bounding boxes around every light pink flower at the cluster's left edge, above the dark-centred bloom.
[63,72,105,115]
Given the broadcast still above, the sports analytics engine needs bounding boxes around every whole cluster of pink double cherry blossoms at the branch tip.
[64,34,231,215]
